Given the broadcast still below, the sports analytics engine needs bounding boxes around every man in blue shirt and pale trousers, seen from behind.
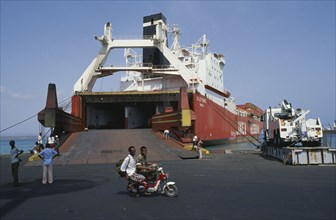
[38,144,58,184]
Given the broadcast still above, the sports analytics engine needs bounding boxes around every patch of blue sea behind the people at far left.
[0,136,45,155]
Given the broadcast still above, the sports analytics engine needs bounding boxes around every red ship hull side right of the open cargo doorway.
[152,87,262,146]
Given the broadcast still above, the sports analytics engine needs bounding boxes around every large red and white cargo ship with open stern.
[38,13,263,146]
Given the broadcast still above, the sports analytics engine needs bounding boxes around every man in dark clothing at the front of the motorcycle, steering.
[136,146,158,179]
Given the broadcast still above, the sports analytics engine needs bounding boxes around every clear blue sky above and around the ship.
[0,1,336,136]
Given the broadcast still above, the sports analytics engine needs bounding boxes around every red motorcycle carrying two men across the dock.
[127,166,178,197]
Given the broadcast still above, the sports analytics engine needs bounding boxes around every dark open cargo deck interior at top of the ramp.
[78,91,179,129]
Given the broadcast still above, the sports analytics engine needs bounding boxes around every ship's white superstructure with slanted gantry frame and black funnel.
[74,14,242,114]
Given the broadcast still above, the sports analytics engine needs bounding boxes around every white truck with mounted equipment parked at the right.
[264,100,323,147]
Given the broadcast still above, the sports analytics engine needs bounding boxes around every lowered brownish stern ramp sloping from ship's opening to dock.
[29,129,195,165]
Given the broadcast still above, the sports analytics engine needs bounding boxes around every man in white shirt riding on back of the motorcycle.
[120,146,146,192]
